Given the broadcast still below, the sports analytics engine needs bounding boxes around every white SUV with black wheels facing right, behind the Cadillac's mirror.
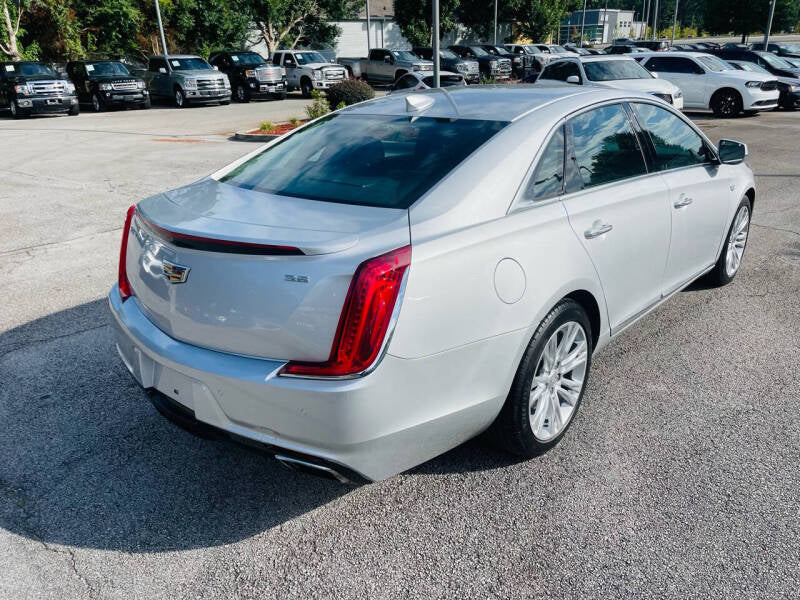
[636,52,780,117]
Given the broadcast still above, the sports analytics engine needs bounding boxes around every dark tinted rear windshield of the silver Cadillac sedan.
[221,113,508,209]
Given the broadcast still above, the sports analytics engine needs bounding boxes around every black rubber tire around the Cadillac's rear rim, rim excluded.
[488,298,593,458]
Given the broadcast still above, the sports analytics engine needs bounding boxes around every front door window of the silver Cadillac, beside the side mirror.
[631,103,707,171]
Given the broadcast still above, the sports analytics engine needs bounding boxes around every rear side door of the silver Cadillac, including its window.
[563,104,670,334]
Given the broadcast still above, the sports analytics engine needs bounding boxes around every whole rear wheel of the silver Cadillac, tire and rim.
[490,298,592,457]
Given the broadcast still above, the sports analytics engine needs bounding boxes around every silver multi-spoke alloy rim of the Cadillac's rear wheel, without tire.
[528,321,589,442]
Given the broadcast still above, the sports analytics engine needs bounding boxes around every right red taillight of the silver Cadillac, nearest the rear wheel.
[280,246,411,377]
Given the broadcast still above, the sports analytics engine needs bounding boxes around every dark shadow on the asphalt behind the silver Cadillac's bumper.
[0,299,353,552]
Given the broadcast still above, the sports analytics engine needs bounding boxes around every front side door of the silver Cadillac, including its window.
[631,102,732,295]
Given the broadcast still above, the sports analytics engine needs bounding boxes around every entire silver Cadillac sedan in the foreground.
[108,85,755,481]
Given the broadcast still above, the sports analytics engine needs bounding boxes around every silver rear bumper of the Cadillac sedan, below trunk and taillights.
[108,286,529,480]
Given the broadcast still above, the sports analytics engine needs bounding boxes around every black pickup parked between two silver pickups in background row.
[208,50,287,102]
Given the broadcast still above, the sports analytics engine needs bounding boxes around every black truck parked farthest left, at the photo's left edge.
[0,61,80,119]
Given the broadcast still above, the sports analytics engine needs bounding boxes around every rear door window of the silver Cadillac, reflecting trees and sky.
[569,104,647,188]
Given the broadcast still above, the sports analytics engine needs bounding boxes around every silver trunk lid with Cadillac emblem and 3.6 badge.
[126,178,410,361]
